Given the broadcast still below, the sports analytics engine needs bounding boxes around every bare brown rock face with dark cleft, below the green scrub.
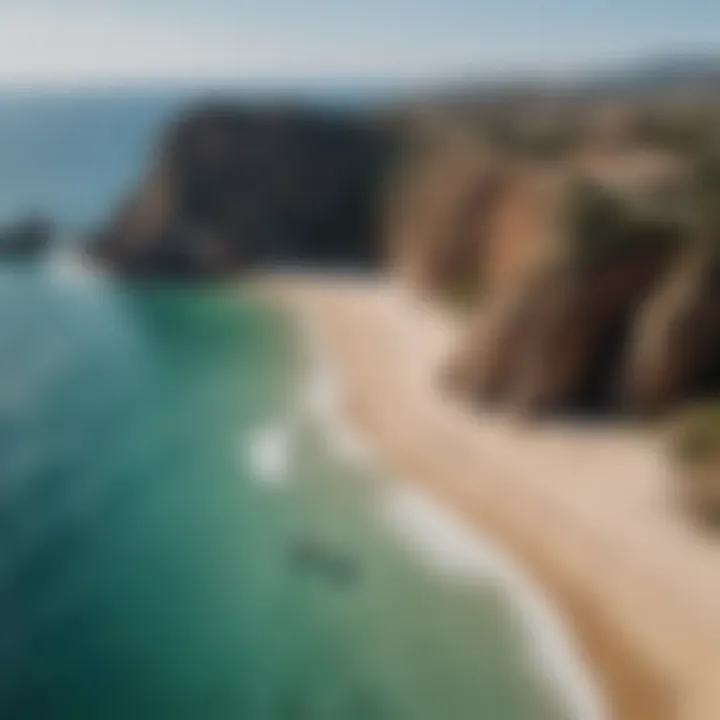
[456,242,672,414]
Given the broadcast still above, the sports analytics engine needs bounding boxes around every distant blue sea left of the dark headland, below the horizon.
[0,90,190,233]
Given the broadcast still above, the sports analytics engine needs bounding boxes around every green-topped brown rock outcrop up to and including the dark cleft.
[448,168,680,413]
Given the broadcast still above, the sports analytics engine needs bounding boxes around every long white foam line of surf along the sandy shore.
[302,310,609,720]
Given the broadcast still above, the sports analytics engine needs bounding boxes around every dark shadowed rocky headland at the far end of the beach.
[94,104,388,276]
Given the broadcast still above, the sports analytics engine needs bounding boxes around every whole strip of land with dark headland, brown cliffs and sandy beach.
[89,85,720,720]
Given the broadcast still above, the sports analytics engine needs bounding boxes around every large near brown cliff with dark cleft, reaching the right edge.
[450,158,720,414]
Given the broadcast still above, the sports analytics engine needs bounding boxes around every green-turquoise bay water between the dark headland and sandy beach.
[0,266,571,720]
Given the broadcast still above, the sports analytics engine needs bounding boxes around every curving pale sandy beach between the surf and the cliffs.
[265,276,720,720]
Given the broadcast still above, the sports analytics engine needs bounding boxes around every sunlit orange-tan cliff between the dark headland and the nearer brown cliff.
[385,118,576,302]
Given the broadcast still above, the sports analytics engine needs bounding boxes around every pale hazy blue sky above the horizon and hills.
[0,0,720,83]
